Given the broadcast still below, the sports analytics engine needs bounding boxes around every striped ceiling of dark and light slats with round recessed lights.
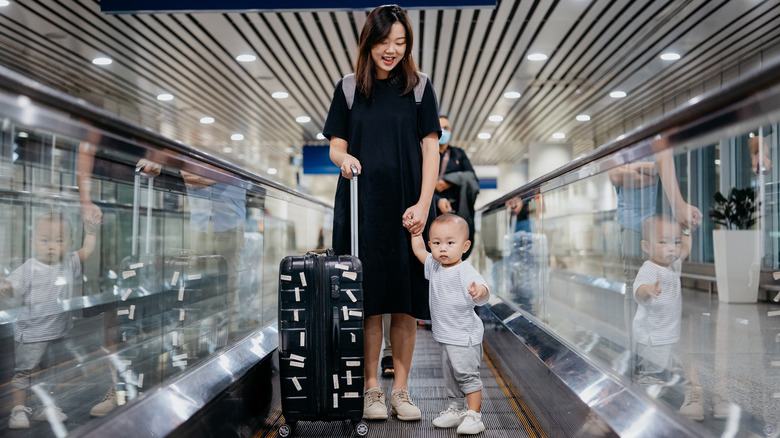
[0,0,780,180]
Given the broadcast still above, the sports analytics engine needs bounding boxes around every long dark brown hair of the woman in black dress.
[355,5,420,97]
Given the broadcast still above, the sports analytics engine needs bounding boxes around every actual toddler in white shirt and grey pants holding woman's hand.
[404,213,490,435]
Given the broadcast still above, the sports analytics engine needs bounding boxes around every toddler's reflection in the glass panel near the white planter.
[632,215,704,420]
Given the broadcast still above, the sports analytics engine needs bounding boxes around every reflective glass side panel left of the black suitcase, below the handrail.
[0,95,331,436]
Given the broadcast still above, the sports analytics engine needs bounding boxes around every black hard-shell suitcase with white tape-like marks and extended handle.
[279,169,368,437]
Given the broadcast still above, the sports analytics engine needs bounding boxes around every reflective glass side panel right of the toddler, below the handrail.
[475,114,780,436]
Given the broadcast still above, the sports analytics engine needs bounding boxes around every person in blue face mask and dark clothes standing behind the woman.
[434,115,479,260]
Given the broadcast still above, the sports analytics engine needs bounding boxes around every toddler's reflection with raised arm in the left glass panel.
[0,213,98,429]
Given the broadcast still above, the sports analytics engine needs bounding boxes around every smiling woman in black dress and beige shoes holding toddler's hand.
[323,5,441,421]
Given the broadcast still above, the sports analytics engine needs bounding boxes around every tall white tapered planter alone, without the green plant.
[712,230,761,303]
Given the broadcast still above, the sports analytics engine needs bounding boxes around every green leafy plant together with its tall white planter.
[709,187,761,303]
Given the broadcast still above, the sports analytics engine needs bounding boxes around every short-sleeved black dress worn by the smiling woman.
[322,80,441,319]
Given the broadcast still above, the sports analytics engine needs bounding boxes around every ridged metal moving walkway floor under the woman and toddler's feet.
[255,327,547,438]
